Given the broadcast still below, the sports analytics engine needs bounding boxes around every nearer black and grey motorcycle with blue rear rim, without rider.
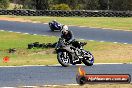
[55,38,94,67]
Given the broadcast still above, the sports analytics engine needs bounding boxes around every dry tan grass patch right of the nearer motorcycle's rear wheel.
[93,45,132,63]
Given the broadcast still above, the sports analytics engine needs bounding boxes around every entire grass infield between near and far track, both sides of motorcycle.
[0,31,132,66]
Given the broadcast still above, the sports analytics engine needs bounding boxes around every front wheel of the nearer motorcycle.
[57,52,70,67]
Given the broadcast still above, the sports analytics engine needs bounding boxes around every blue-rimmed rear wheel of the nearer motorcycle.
[82,51,94,66]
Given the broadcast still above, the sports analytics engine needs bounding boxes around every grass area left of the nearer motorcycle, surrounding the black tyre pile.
[0,32,57,65]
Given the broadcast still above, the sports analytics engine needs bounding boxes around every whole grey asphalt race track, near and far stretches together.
[0,21,132,87]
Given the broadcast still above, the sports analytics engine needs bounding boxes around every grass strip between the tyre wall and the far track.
[1,16,132,30]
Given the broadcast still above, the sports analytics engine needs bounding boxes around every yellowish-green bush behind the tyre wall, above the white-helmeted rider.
[50,4,71,10]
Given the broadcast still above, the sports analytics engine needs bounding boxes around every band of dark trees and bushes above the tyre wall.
[4,0,132,11]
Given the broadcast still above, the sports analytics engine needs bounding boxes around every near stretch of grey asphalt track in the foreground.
[0,64,132,87]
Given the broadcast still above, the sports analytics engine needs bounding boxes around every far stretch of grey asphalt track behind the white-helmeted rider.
[0,21,132,44]
